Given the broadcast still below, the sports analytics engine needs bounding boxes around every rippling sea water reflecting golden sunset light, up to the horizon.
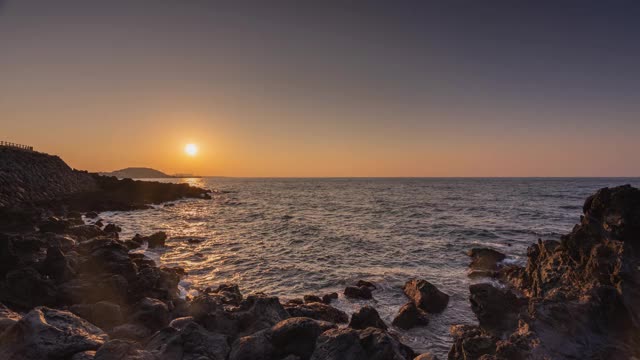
[101,178,640,358]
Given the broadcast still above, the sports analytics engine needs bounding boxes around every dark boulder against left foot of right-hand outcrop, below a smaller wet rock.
[469,284,526,334]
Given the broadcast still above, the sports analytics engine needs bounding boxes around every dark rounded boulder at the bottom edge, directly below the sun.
[145,321,230,360]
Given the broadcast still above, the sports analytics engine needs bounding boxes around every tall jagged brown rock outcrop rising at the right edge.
[449,186,640,359]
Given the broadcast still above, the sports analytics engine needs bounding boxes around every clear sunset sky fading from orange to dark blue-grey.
[0,0,640,177]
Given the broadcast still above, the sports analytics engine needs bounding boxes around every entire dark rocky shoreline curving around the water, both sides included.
[0,150,640,360]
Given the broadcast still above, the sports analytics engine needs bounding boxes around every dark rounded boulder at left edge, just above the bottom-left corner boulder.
[0,267,58,309]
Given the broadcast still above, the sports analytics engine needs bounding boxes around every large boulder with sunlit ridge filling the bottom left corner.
[0,307,108,359]
